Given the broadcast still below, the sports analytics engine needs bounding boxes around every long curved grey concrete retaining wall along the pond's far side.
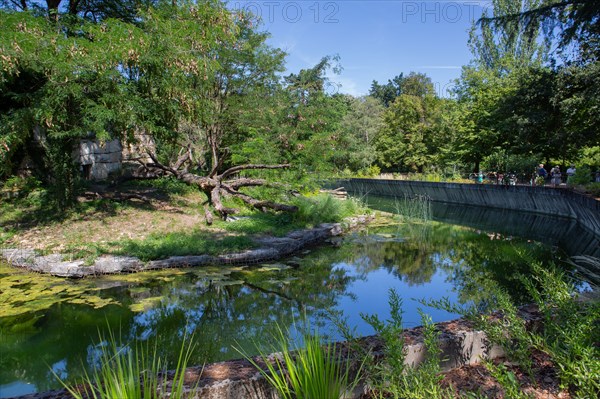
[333,179,600,235]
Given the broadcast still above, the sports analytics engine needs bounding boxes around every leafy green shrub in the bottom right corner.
[424,260,600,398]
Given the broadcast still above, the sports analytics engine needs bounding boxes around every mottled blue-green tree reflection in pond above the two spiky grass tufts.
[121,262,351,363]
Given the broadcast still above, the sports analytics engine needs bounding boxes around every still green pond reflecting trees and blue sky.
[0,198,598,397]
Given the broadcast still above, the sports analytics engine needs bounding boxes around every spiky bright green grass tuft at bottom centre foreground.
[238,327,361,399]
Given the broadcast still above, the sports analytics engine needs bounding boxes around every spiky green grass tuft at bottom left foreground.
[55,331,194,399]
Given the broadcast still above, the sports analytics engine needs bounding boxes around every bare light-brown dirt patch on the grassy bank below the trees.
[3,187,216,253]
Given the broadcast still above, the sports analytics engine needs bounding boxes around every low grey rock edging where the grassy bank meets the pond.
[0,216,373,278]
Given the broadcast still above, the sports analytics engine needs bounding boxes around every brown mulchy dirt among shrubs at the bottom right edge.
[442,352,573,399]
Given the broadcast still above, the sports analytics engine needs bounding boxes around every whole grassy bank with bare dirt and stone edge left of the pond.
[0,178,366,277]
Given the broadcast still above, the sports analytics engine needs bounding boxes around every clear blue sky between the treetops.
[230,0,490,96]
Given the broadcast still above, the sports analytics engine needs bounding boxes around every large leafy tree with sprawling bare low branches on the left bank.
[0,1,295,223]
